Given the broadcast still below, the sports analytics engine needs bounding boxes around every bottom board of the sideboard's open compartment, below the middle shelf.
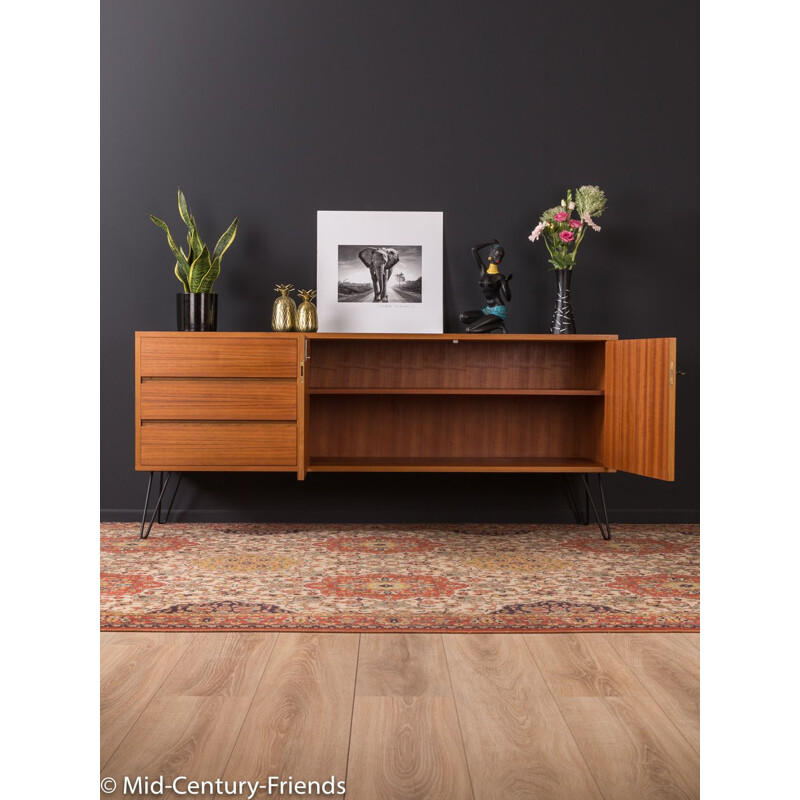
[308,456,613,472]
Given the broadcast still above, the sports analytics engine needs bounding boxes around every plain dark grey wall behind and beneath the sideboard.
[101,0,699,522]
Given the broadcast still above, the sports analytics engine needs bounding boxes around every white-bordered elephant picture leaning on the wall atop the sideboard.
[317,211,444,333]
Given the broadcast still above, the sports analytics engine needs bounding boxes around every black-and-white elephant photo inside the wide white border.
[339,245,422,304]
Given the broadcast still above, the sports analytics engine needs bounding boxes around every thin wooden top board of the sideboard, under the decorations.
[136,331,619,342]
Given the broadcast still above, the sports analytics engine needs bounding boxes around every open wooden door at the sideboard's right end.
[604,339,675,481]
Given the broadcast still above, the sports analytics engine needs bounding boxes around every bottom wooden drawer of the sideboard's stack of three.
[140,422,297,469]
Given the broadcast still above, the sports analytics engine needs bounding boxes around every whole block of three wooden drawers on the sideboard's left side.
[136,332,304,477]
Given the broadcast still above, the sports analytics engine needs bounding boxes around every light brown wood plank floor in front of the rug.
[100,633,700,800]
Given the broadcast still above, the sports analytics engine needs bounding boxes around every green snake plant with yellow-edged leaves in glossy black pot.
[150,189,239,331]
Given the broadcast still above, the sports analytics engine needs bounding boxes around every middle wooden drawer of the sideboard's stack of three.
[139,378,297,420]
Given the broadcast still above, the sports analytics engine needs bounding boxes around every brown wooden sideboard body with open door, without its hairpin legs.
[135,332,675,481]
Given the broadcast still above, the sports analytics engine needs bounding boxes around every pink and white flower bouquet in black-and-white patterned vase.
[528,186,606,333]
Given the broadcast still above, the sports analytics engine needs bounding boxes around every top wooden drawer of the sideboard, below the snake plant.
[139,333,297,378]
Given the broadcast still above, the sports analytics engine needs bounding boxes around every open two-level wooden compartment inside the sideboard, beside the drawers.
[306,340,605,471]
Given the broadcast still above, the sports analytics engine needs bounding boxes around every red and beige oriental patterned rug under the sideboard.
[101,523,700,632]
